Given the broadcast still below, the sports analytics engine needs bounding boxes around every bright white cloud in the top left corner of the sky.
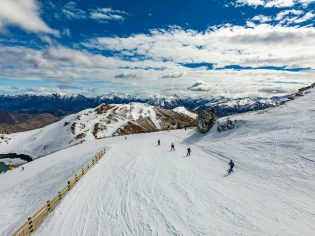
[0,0,58,35]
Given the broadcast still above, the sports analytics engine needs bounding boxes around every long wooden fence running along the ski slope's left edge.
[13,150,105,236]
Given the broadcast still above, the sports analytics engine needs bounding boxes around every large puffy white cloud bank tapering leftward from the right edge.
[87,24,315,68]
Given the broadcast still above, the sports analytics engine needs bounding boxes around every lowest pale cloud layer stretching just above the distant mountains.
[0,42,314,97]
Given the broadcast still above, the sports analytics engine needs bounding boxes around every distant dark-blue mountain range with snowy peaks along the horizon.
[0,94,287,116]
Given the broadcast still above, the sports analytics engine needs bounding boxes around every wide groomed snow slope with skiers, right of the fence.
[28,90,315,236]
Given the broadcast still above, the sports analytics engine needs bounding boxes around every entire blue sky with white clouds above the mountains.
[0,0,315,97]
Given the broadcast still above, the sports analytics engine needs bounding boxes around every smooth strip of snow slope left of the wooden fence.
[0,143,102,236]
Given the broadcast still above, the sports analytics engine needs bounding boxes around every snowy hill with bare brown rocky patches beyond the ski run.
[0,103,195,158]
